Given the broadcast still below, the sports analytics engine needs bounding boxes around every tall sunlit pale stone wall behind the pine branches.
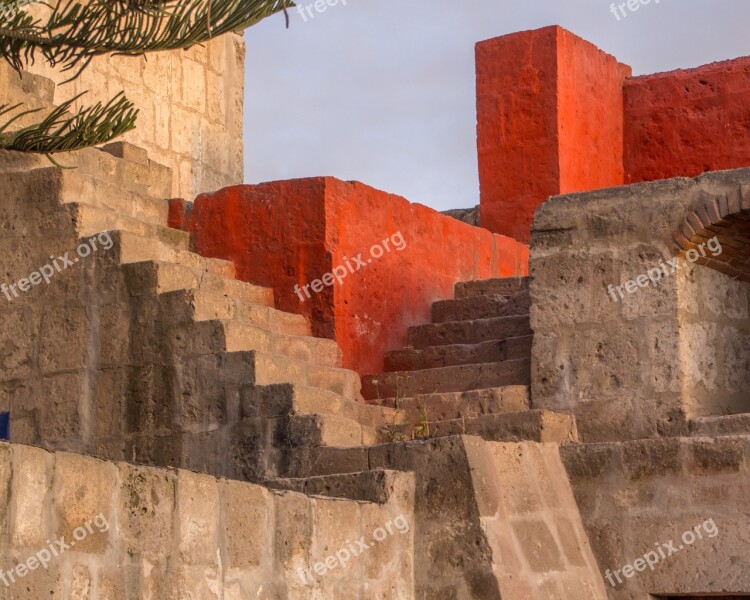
[0,9,245,199]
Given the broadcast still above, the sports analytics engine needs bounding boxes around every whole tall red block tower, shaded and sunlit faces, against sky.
[476,26,630,243]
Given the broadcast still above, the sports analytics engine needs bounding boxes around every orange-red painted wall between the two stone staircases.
[175,178,528,374]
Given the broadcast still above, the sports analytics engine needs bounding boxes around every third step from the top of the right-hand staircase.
[407,315,532,349]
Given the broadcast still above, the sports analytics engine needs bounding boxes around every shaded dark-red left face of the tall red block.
[476,27,560,243]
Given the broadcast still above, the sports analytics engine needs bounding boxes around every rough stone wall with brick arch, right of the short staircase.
[530,170,750,441]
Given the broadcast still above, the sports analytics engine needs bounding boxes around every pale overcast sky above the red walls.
[245,0,750,210]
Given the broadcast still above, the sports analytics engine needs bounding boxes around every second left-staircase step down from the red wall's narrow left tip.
[112,228,234,279]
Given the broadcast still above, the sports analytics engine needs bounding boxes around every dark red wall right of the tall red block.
[624,57,750,183]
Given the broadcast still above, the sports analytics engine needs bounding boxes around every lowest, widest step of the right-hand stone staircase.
[378,410,578,443]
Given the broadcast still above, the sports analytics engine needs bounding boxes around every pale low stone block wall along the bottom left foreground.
[0,444,414,600]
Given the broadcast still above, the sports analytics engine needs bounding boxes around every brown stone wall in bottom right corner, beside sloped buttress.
[561,435,750,600]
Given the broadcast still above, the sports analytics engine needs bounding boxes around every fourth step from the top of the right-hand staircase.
[385,335,533,372]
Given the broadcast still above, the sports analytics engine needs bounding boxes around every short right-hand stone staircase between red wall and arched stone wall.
[362,277,577,442]
